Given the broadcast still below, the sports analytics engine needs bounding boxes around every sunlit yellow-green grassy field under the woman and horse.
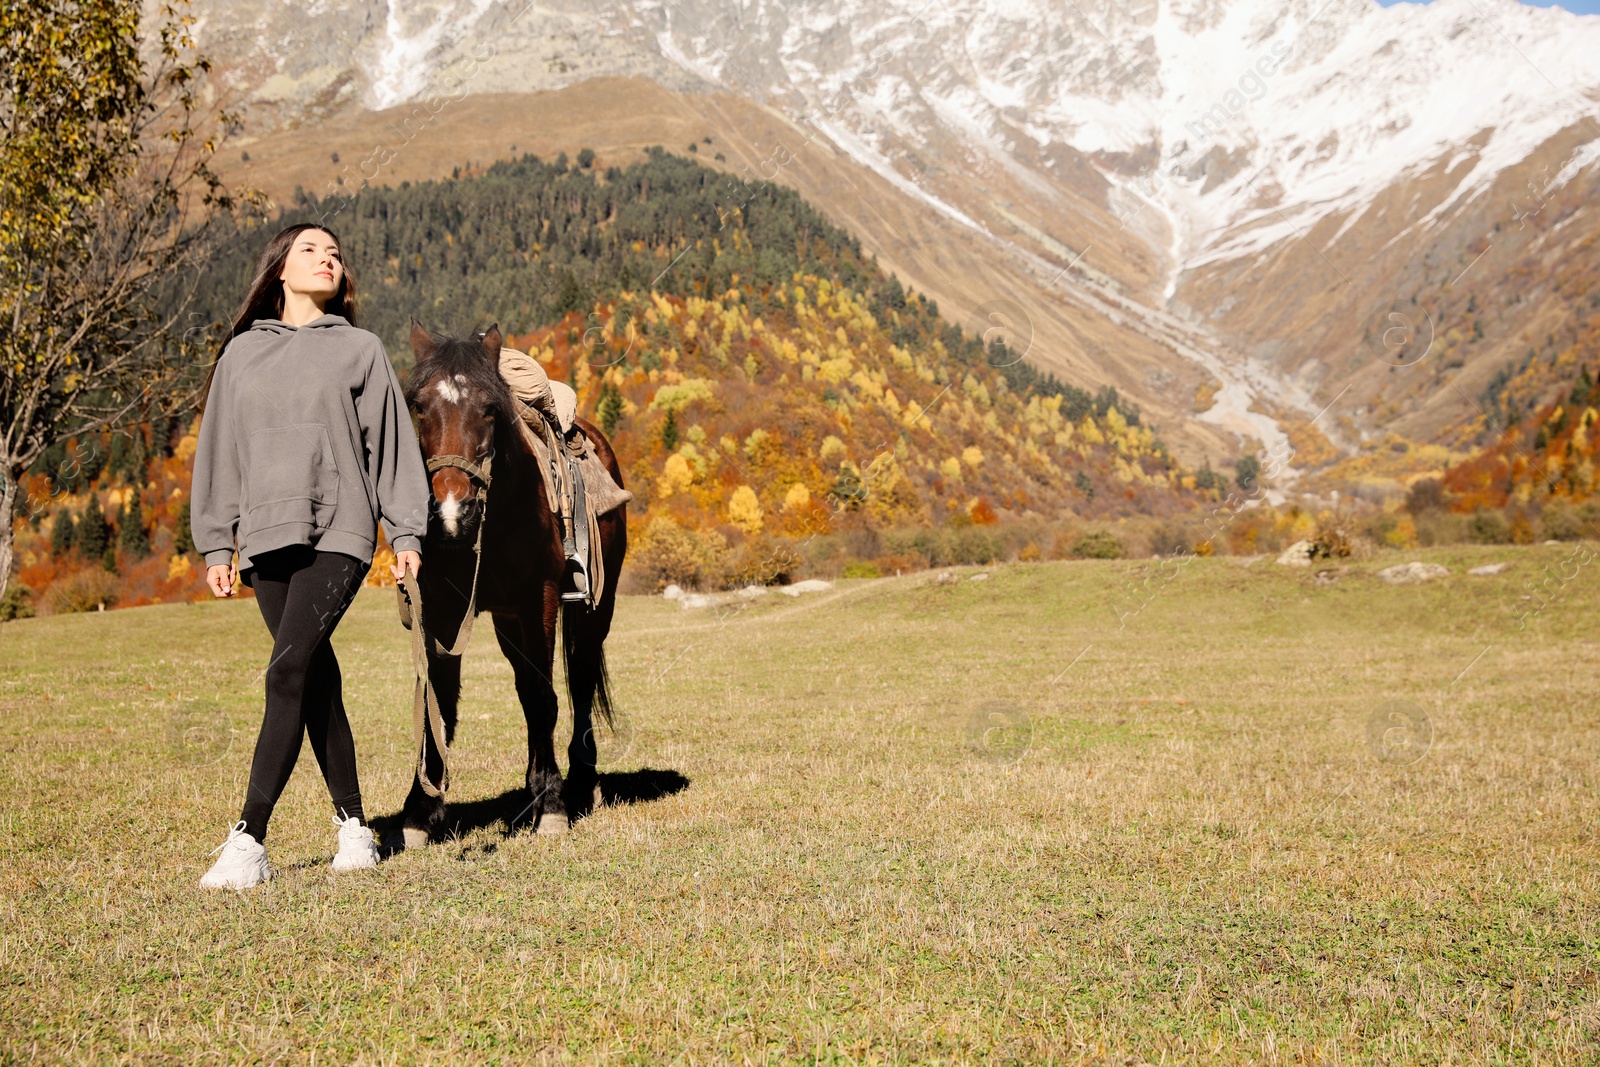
[0,545,1600,1064]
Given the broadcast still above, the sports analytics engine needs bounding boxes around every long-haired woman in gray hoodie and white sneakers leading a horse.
[190,222,429,889]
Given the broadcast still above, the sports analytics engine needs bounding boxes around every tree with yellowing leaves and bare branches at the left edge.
[0,0,264,597]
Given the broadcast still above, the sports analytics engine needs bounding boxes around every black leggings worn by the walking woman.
[240,544,368,841]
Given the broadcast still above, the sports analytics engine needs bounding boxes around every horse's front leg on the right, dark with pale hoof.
[494,598,568,833]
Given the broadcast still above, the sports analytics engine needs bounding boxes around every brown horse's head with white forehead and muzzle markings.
[405,318,515,541]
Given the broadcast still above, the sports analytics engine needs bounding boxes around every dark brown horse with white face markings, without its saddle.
[402,318,627,848]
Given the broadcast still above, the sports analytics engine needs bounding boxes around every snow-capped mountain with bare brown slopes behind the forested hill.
[152,0,1600,462]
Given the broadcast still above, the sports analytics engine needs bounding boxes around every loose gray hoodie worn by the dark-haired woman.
[189,315,429,571]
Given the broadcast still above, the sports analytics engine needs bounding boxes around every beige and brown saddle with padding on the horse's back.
[499,347,634,608]
